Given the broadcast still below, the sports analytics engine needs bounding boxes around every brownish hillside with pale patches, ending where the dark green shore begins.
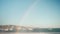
[0,25,32,31]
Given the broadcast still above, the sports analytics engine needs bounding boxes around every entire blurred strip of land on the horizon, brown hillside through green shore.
[0,25,60,32]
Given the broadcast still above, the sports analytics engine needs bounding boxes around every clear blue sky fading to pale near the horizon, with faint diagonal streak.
[0,0,60,27]
